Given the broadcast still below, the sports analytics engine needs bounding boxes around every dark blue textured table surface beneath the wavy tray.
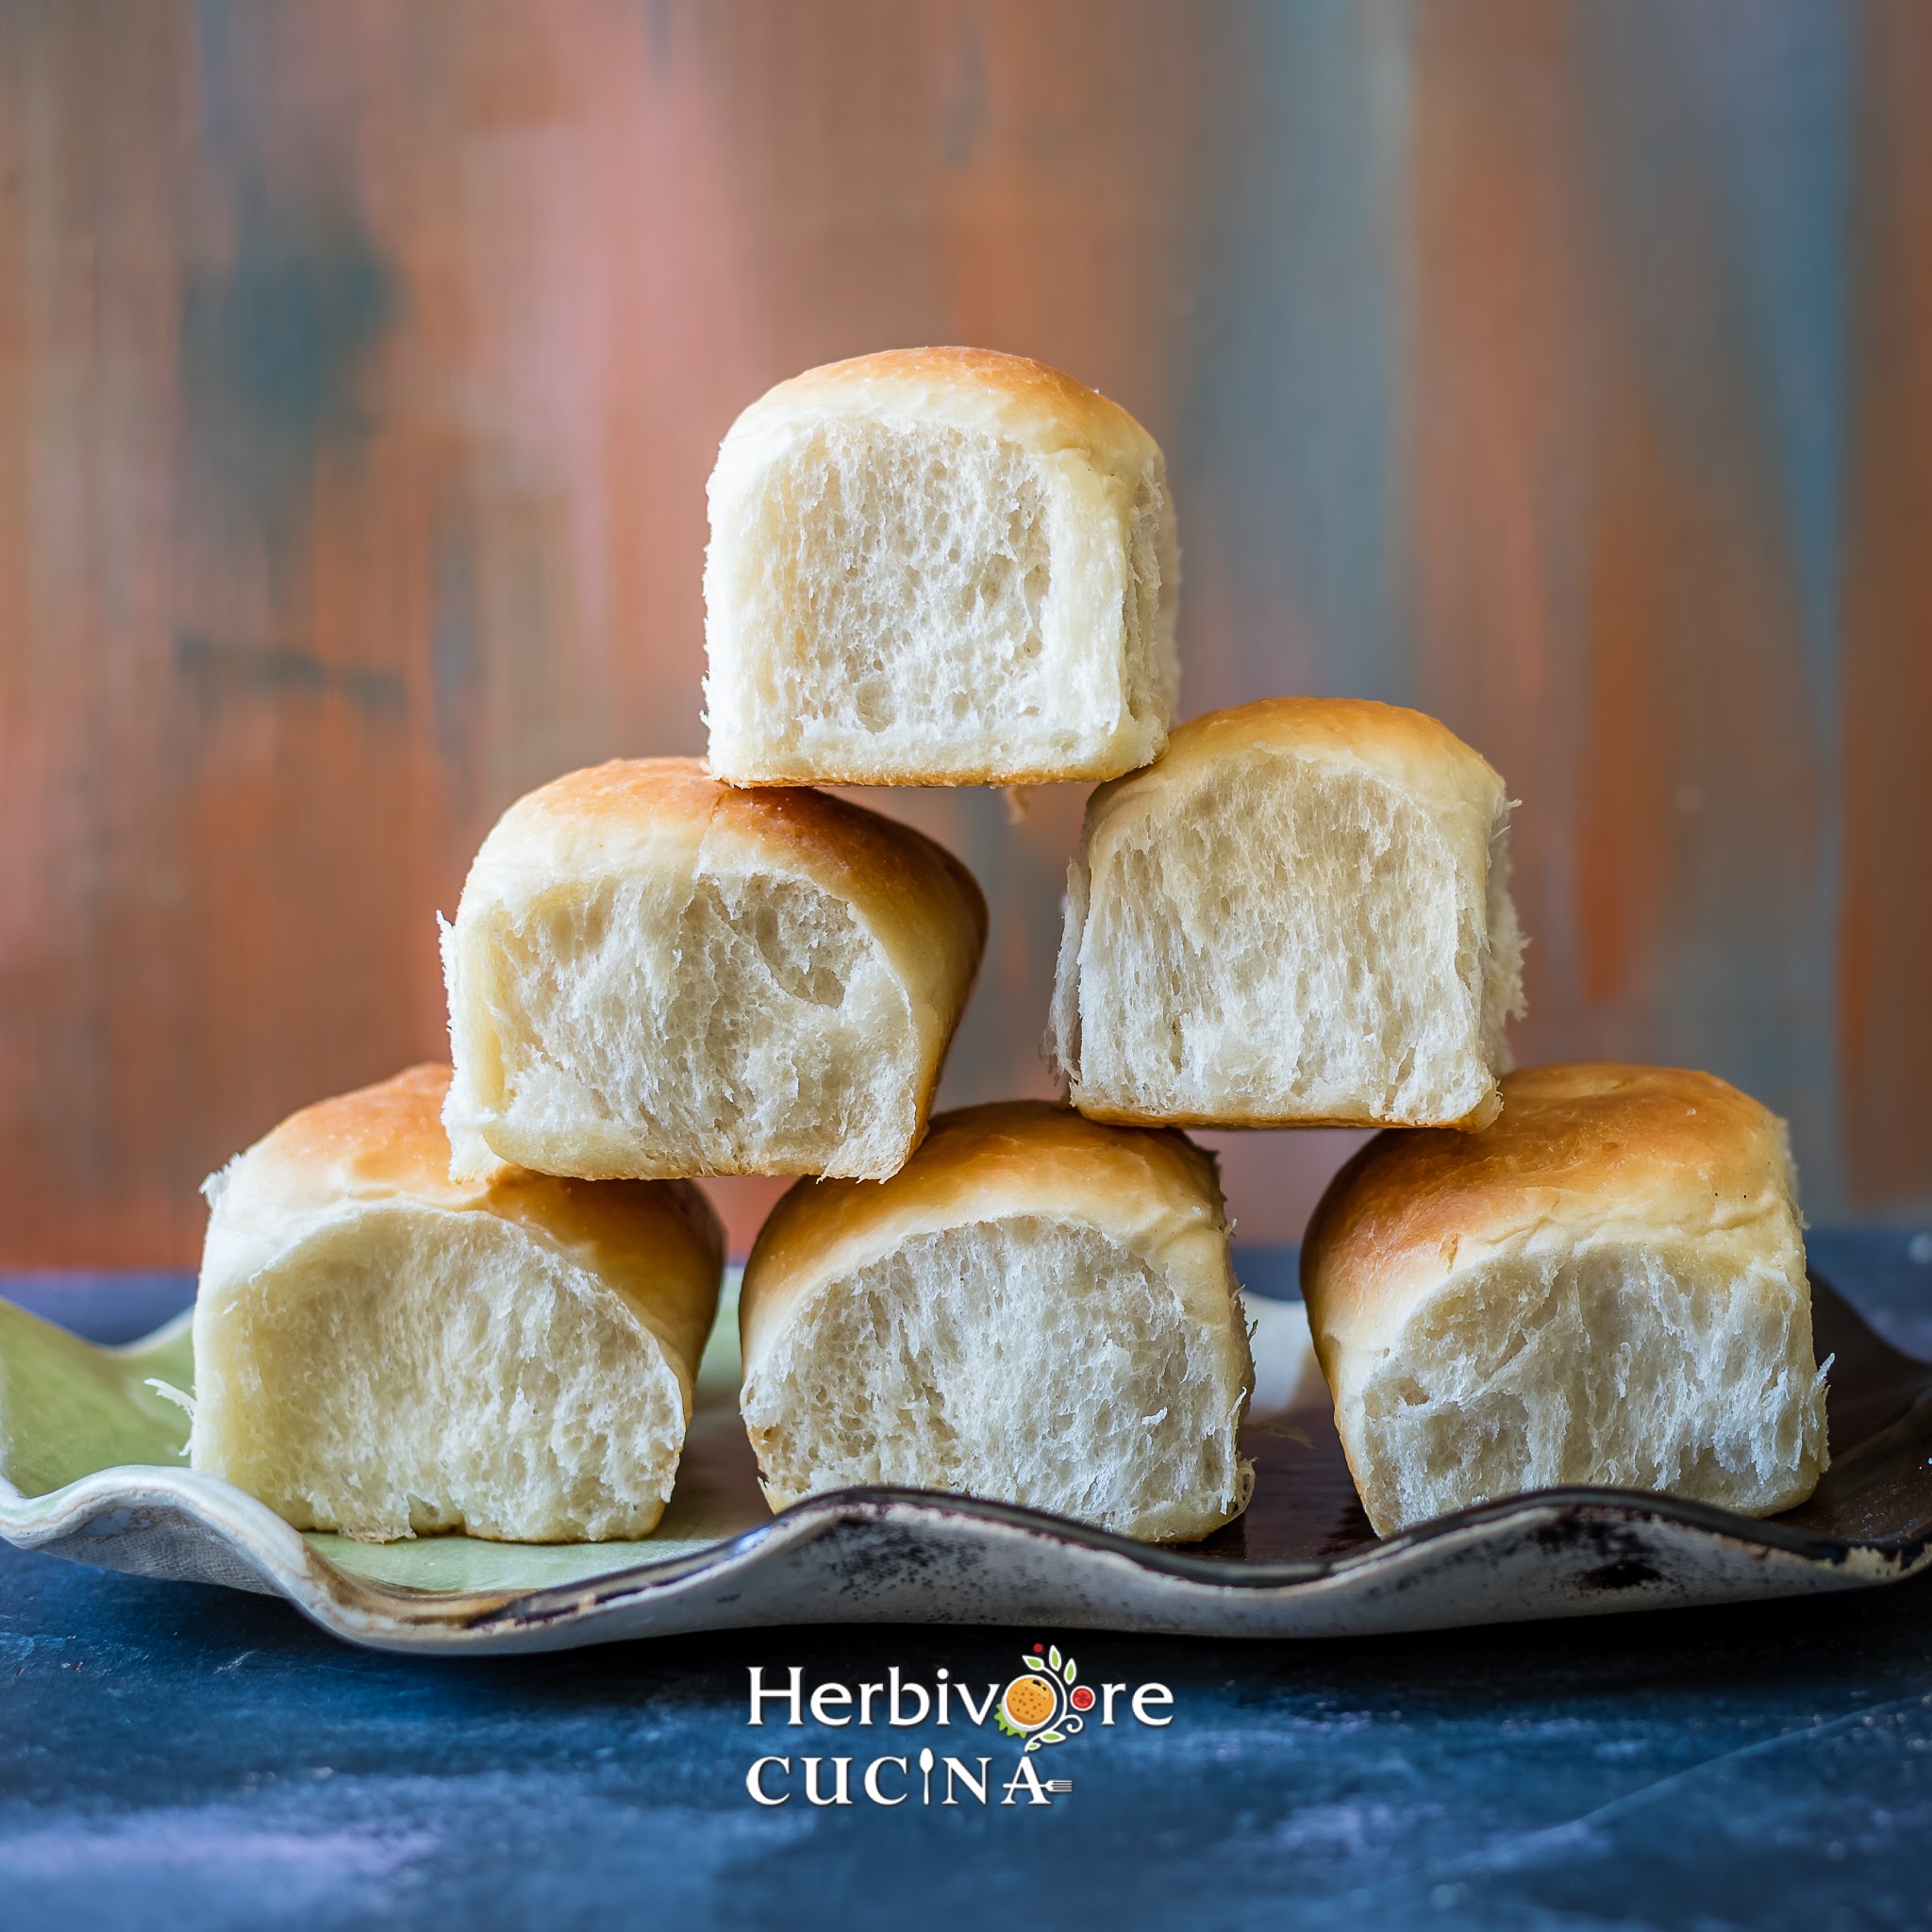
[0,1235,1932,1932]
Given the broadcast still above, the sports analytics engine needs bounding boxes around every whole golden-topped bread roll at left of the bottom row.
[190,1066,724,1543]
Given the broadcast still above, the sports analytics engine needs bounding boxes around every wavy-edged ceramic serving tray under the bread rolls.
[0,1277,1932,1652]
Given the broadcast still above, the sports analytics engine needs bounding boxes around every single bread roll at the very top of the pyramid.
[706,350,1180,784]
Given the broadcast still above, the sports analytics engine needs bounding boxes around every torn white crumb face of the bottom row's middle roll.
[743,1215,1252,1540]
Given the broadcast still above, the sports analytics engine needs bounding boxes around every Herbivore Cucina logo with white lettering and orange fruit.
[743,1644,1174,1808]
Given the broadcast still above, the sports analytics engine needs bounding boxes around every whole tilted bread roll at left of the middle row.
[442,758,985,1180]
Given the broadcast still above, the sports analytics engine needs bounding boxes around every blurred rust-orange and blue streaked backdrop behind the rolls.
[0,0,1932,1263]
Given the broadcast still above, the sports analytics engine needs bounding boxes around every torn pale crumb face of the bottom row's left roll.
[192,1202,690,1541]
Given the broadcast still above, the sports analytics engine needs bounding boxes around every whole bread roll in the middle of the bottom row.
[738,1101,1254,1540]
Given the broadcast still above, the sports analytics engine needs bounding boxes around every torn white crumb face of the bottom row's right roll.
[1335,1241,1825,1536]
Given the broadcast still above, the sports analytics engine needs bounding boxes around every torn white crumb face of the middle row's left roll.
[448,872,924,1178]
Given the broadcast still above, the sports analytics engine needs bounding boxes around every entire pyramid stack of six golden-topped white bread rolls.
[192,350,1824,1540]
